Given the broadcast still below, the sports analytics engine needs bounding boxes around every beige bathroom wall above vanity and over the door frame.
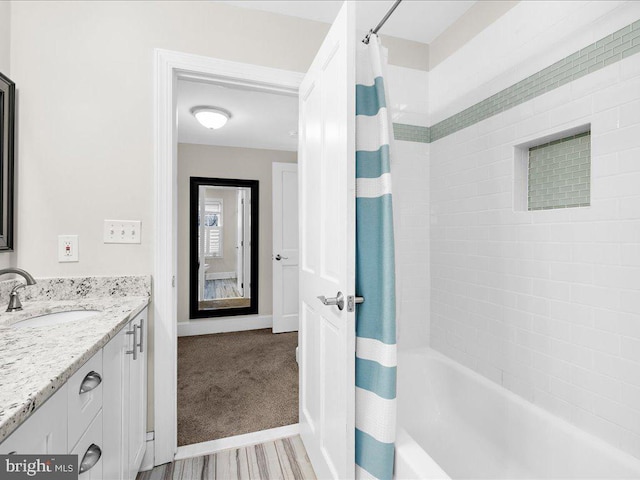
[6,0,426,436]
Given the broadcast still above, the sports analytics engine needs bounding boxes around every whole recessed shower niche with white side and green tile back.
[514,125,591,211]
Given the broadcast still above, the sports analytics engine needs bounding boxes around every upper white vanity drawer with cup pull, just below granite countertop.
[67,350,103,447]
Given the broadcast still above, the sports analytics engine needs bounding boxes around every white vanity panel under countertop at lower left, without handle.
[0,384,67,455]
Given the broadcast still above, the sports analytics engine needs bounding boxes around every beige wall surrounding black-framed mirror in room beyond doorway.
[177,143,297,322]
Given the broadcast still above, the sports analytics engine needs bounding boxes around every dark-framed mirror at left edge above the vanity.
[0,73,16,251]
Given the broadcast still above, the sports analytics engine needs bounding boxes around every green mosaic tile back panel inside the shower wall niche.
[527,132,591,210]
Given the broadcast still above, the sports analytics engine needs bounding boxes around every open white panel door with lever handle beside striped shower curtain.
[298,2,356,479]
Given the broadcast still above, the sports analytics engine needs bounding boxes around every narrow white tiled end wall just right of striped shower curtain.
[387,65,431,349]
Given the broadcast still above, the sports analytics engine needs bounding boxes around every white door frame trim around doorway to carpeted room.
[152,49,303,465]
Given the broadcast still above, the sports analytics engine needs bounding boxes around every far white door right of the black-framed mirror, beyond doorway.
[272,163,300,333]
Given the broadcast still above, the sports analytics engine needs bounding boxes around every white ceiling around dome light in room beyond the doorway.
[178,80,298,151]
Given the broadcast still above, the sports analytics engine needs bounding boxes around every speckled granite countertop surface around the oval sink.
[0,280,149,442]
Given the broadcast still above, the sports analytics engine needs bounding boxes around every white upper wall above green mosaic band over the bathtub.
[429,0,640,124]
